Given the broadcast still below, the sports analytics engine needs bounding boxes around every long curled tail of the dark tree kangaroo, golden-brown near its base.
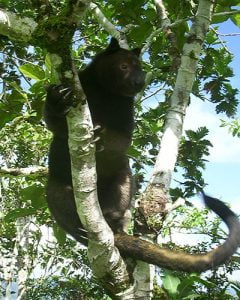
[115,193,240,272]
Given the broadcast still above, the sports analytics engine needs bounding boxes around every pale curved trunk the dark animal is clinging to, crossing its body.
[67,104,129,291]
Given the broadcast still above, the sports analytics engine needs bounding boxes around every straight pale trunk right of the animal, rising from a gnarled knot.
[143,0,213,214]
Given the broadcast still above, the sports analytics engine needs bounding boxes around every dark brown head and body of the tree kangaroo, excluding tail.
[45,39,145,241]
